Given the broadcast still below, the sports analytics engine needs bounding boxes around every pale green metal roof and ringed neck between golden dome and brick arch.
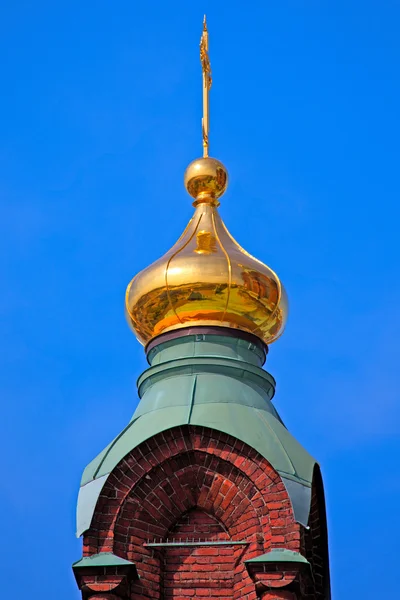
[78,334,315,535]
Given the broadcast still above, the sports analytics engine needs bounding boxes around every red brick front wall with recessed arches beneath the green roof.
[84,426,324,600]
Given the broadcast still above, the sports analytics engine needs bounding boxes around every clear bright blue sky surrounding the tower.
[0,0,400,600]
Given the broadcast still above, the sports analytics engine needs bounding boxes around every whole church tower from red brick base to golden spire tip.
[73,22,330,600]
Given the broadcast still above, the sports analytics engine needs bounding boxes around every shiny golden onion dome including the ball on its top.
[126,157,288,344]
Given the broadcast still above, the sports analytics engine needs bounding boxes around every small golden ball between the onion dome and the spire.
[184,158,228,199]
